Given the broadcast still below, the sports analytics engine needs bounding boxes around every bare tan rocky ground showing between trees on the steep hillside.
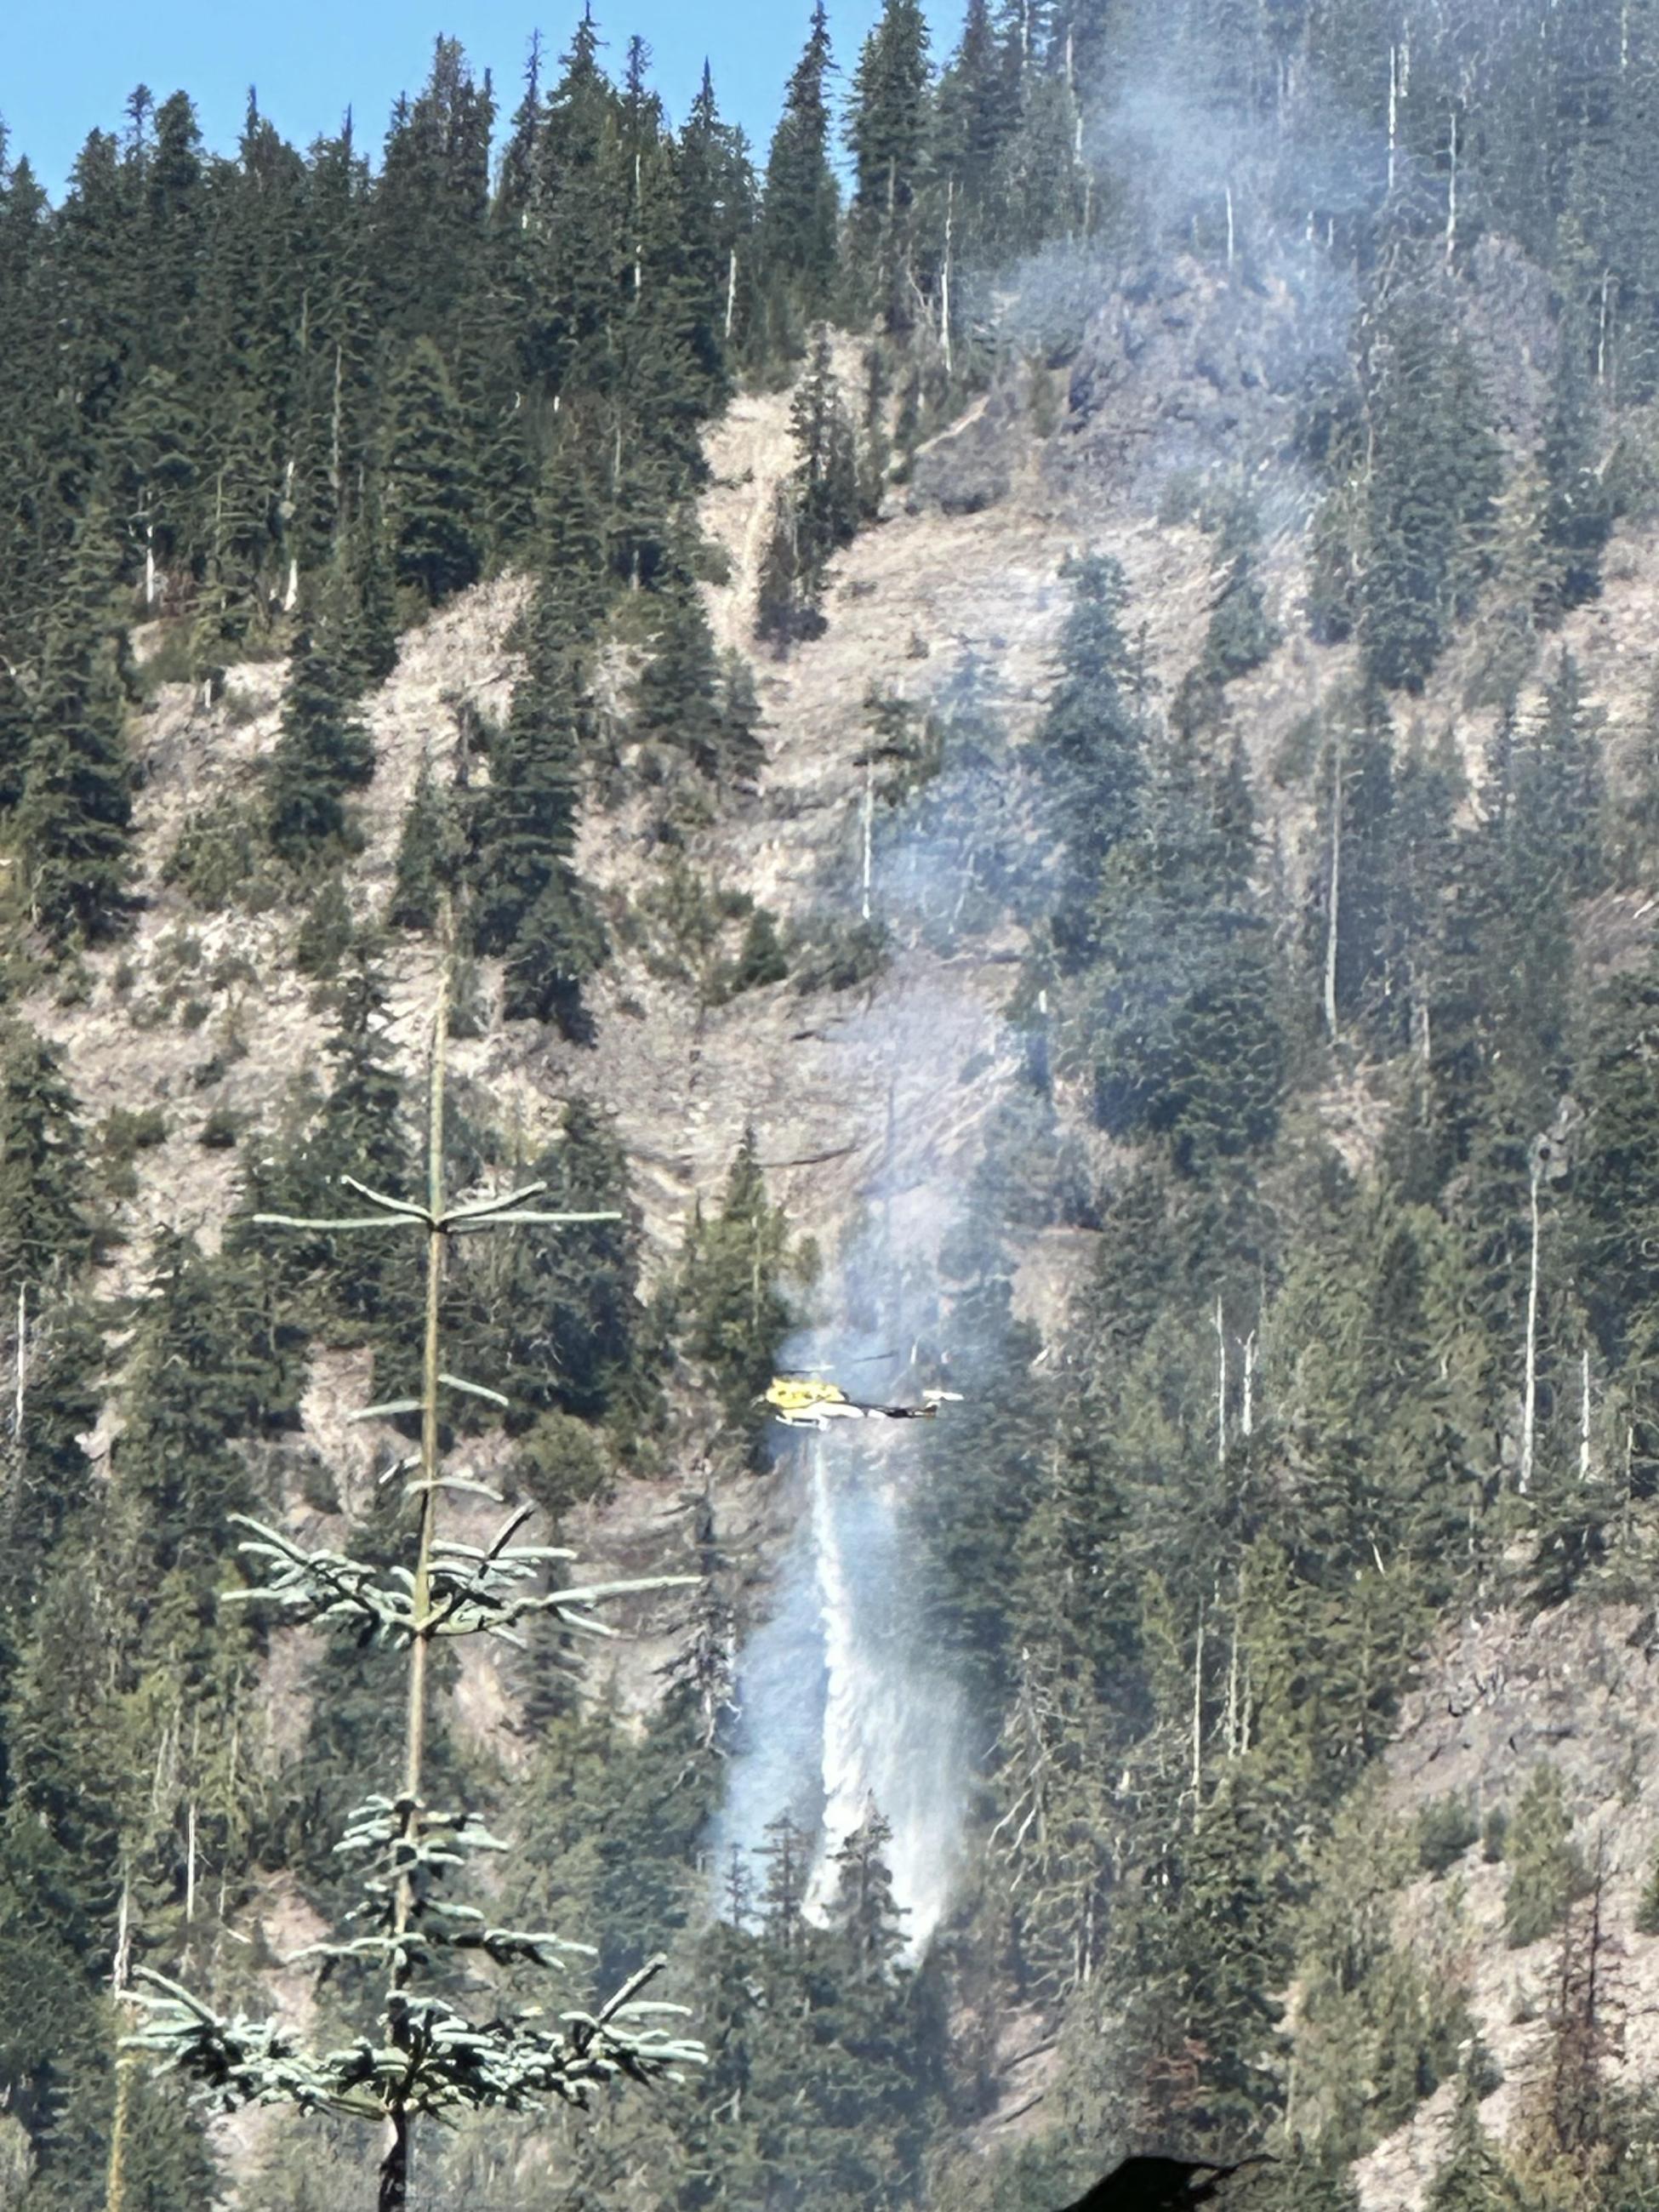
[35,263,1659,2212]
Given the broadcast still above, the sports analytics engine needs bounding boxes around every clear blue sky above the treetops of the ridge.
[0,0,962,199]
